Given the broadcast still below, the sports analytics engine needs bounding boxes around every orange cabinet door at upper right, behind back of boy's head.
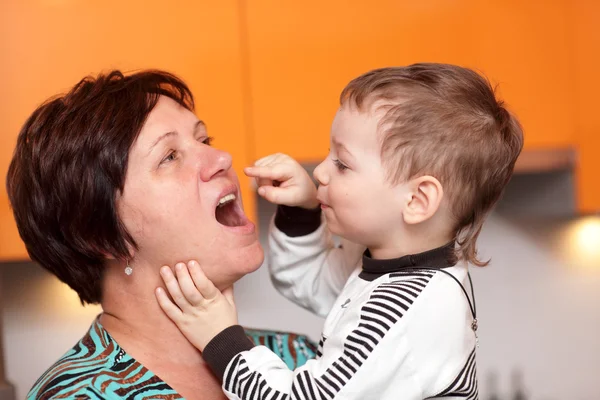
[471,0,575,149]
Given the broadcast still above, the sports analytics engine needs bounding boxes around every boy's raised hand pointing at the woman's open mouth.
[244,153,319,209]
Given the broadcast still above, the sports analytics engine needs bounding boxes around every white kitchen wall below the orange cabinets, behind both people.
[0,173,600,400]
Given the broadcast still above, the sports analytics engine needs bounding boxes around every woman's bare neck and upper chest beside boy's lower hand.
[99,265,225,400]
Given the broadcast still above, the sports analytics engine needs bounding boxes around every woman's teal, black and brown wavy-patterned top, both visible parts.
[27,318,316,400]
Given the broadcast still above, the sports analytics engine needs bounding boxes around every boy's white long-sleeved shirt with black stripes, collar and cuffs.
[205,208,478,400]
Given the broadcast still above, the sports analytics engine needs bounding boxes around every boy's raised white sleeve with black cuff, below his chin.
[267,205,364,317]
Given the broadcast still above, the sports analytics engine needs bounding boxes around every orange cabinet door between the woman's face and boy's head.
[247,0,480,161]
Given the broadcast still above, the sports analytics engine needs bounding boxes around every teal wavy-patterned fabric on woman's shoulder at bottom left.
[27,320,181,400]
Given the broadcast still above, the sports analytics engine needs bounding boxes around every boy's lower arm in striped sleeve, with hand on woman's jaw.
[156,262,424,400]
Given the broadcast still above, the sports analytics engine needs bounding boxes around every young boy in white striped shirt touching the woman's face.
[157,64,523,400]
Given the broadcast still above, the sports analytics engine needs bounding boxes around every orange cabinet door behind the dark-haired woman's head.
[0,0,254,260]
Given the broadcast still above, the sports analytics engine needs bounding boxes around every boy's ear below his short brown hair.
[403,175,444,225]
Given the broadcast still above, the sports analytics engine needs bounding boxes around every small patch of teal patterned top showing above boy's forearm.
[245,328,317,369]
